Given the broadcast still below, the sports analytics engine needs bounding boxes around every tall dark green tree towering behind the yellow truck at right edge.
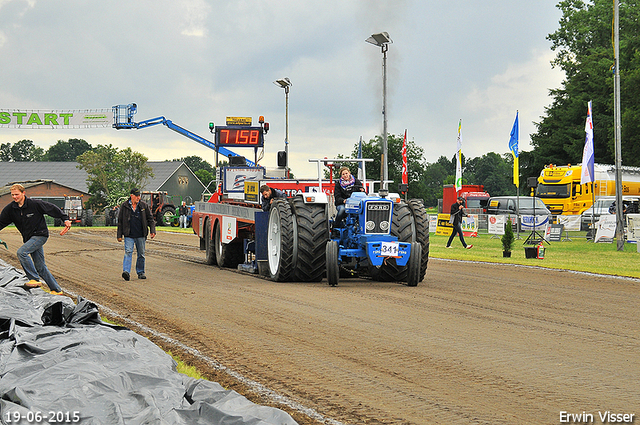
[531,0,640,172]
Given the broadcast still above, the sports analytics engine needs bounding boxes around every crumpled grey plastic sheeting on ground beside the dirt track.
[0,263,296,425]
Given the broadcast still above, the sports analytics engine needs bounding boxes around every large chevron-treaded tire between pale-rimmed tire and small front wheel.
[292,196,329,282]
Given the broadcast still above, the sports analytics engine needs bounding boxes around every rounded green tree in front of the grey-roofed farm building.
[77,145,153,211]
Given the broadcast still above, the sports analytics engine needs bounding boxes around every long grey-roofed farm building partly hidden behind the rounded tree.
[0,161,205,208]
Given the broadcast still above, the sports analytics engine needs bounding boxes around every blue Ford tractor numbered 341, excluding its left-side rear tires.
[325,190,429,286]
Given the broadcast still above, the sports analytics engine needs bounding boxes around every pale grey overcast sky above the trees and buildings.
[0,0,563,177]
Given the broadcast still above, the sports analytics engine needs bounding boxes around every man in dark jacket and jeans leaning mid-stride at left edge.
[0,184,71,295]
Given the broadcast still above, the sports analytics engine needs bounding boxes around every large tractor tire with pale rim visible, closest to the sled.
[267,198,294,282]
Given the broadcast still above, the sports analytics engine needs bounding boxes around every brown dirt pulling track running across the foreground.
[0,228,640,424]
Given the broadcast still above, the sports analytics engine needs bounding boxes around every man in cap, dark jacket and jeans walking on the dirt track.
[118,189,156,280]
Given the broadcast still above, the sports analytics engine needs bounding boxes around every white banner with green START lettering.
[0,108,113,130]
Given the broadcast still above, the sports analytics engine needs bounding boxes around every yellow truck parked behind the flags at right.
[536,164,640,215]
